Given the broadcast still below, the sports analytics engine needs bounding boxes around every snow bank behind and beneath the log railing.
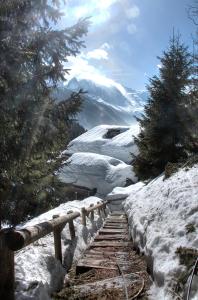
[15,197,105,300]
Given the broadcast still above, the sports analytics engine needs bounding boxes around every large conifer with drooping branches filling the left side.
[0,0,88,223]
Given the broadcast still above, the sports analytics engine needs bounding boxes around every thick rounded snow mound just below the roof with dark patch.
[59,152,137,196]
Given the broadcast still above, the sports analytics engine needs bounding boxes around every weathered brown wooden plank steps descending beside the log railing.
[54,212,150,300]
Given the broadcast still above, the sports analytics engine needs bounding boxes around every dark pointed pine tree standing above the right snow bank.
[133,36,192,179]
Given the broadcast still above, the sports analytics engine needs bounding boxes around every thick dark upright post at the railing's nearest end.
[0,229,15,300]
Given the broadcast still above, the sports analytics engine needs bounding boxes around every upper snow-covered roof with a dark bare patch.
[64,125,139,163]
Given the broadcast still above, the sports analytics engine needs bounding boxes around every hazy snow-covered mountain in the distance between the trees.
[56,78,147,129]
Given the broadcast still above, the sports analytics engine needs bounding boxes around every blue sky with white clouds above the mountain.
[62,0,195,90]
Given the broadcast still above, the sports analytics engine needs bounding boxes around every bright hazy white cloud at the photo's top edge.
[65,0,140,35]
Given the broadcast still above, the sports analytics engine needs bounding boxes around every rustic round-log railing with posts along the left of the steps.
[0,202,107,300]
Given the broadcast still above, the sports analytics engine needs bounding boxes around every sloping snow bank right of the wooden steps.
[108,166,198,300]
